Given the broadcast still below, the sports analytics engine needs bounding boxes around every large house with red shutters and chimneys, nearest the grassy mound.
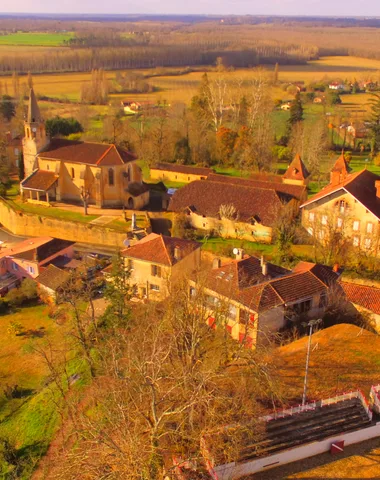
[190,249,339,347]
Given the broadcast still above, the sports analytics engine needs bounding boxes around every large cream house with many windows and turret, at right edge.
[300,154,380,255]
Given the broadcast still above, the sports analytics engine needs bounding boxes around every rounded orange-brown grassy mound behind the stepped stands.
[272,324,380,404]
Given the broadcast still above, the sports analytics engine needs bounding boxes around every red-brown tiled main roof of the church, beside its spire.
[38,138,137,166]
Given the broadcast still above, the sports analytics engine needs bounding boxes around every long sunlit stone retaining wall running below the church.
[0,199,126,247]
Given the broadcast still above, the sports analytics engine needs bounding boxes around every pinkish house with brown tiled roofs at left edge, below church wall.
[0,237,74,295]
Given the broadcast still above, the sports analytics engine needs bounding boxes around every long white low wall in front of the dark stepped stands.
[210,422,380,480]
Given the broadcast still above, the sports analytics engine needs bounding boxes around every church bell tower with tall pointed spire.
[23,88,48,177]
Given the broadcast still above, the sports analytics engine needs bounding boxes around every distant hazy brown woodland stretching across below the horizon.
[0,16,380,74]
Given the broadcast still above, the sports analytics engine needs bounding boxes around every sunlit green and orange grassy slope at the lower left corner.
[0,305,87,479]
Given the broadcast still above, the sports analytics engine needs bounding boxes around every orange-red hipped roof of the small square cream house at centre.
[122,233,201,266]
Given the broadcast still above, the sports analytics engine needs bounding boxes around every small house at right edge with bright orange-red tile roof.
[339,281,380,333]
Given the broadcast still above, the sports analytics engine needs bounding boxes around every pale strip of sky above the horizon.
[0,0,380,17]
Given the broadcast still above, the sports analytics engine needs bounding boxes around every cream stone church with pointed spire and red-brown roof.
[20,89,149,210]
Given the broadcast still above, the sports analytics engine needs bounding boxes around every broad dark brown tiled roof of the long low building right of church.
[169,180,292,226]
